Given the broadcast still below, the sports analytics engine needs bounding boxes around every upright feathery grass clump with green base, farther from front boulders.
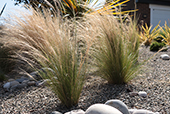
[89,15,140,84]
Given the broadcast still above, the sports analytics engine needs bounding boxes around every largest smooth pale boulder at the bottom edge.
[85,104,122,114]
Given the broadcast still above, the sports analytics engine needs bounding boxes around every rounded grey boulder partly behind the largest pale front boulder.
[105,99,129,114]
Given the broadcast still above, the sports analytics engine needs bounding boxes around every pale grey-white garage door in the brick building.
[150,4,170,27]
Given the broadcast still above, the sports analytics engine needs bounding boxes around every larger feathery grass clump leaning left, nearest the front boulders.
[5,9,90,107]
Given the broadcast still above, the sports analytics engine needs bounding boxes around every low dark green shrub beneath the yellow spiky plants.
[150,41,166,51]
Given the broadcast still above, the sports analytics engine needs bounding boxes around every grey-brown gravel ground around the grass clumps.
[0,47,170,114]
